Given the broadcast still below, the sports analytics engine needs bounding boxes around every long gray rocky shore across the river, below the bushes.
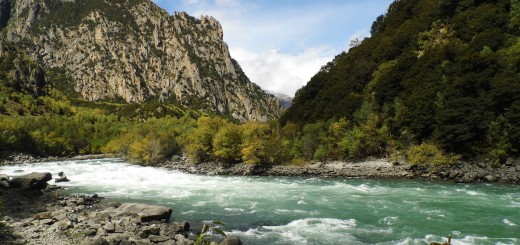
[159,157,520,184]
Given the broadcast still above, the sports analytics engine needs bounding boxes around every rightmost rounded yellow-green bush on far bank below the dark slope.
[406,143,460,166]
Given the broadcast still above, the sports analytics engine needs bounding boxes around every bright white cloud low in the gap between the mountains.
[230,46,337,96]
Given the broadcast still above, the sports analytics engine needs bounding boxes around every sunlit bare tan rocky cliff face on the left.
[0,0,280,121]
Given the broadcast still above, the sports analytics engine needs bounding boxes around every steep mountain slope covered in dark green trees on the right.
[282,0,520,157]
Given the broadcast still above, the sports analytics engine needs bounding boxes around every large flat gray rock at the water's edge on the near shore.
[114,203,172,222]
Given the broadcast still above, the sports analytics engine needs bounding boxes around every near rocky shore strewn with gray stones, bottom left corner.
[0,173,241,245]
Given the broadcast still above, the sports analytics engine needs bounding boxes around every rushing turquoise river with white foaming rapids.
[0,159,520,245]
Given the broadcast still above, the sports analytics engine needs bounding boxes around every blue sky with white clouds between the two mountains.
[152,0,394,96]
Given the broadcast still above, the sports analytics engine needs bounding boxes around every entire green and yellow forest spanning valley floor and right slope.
[0,0,520,165]
